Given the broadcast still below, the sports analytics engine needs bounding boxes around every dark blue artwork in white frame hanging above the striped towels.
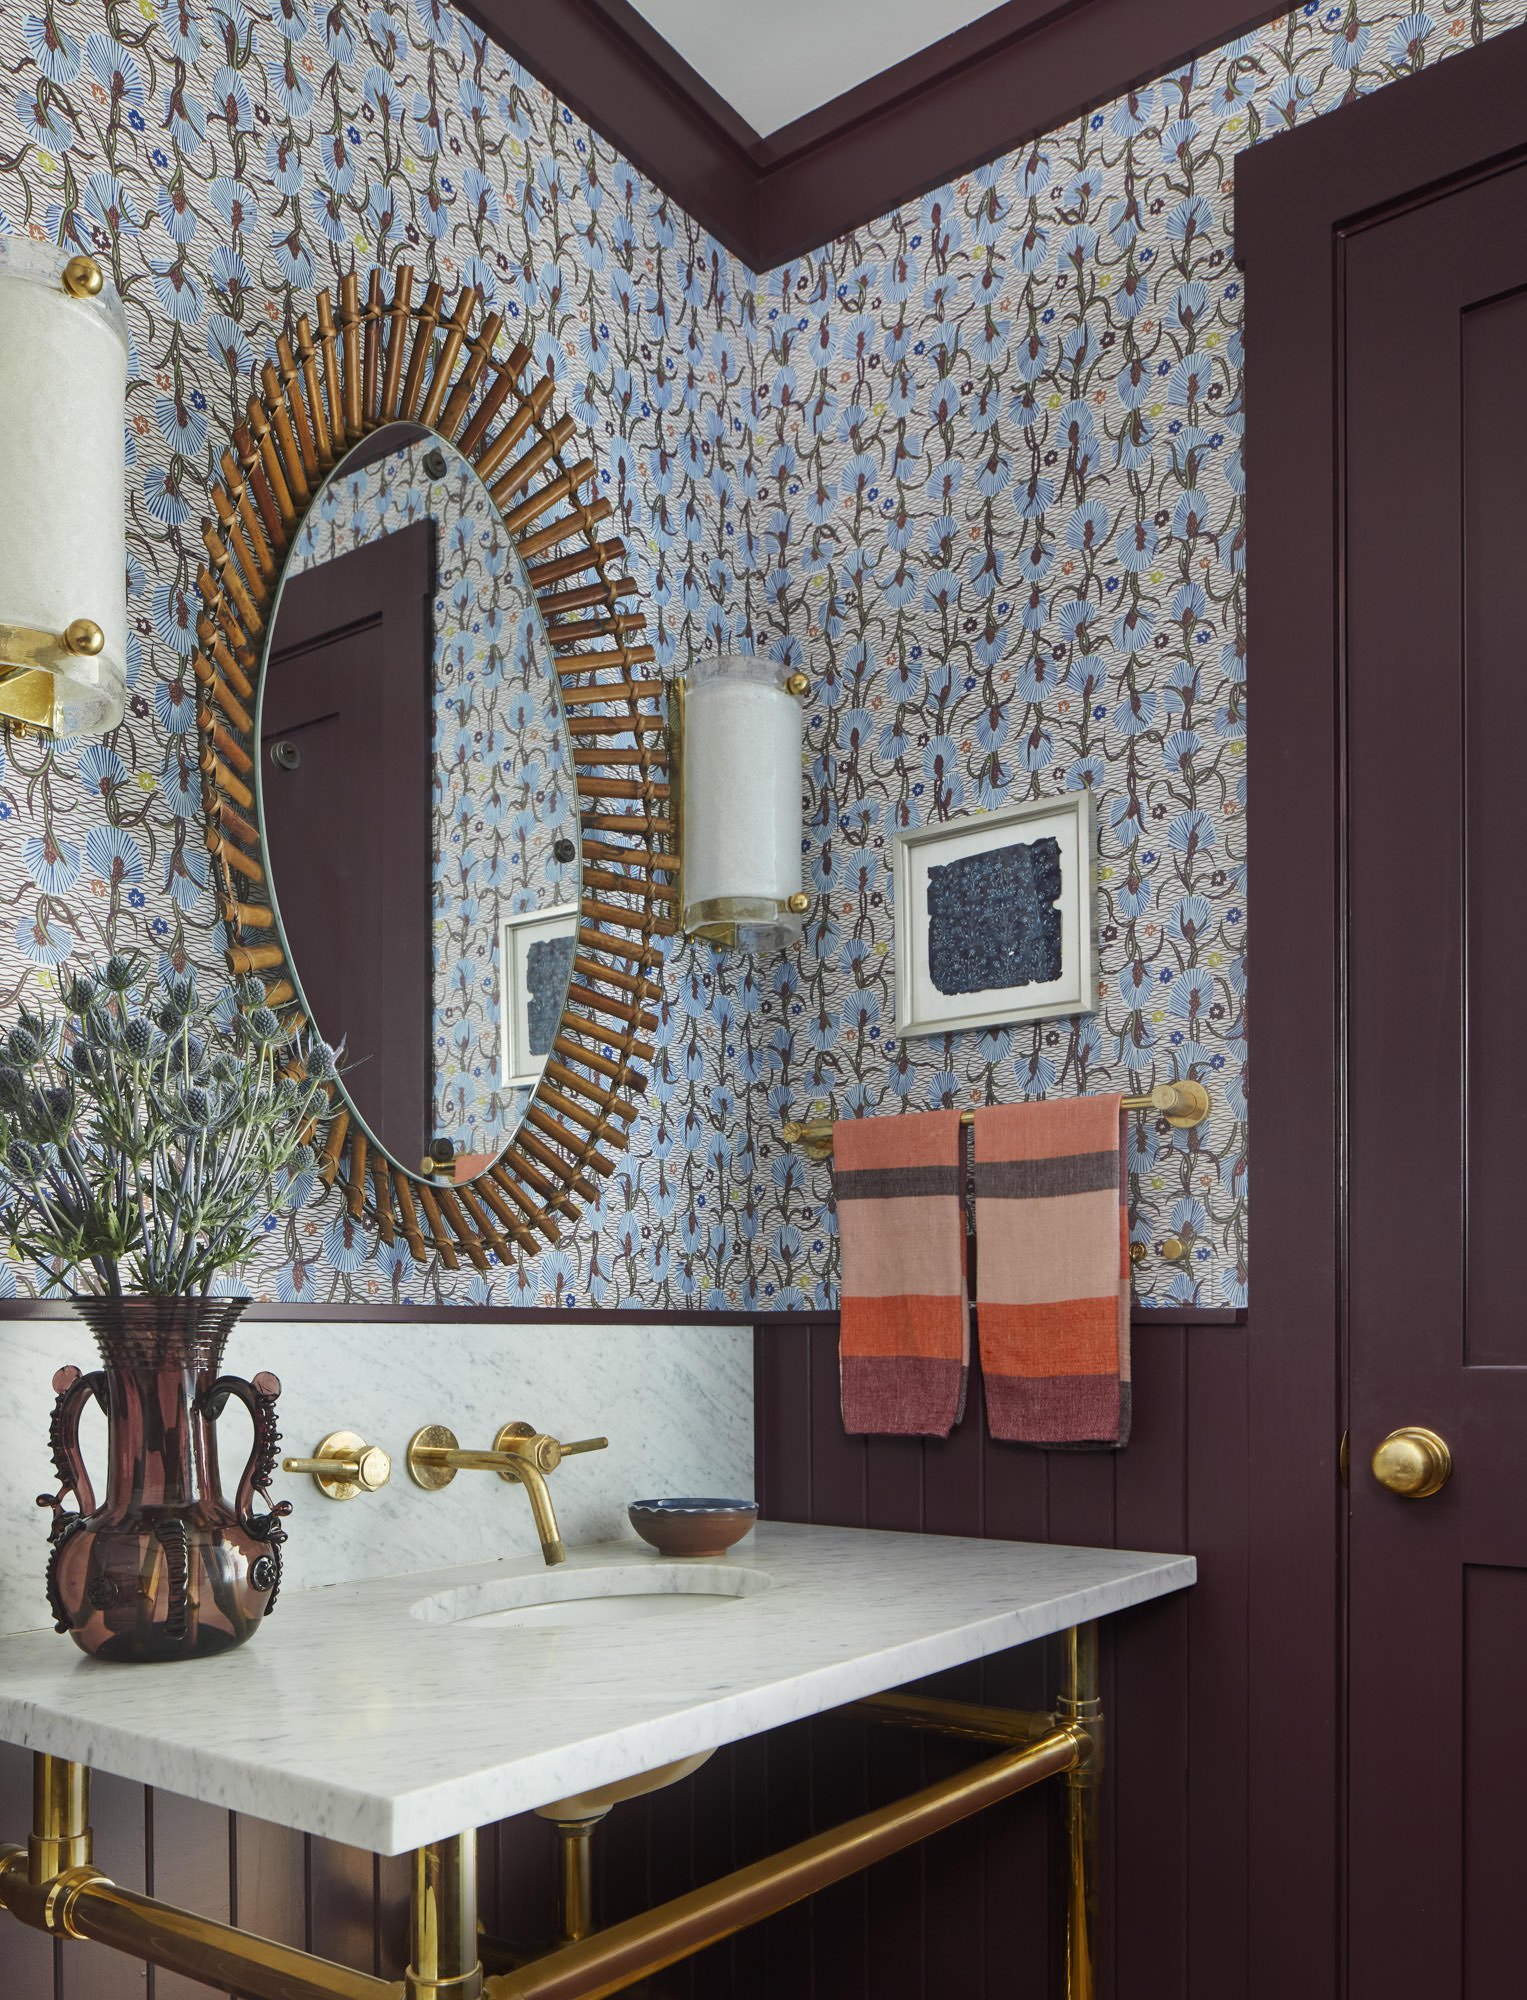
[893,792,1097,1034]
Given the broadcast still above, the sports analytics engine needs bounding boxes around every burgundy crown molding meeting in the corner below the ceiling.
[466,0,1287,272]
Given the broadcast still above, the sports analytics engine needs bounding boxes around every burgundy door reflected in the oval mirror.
[260,520,436,1166]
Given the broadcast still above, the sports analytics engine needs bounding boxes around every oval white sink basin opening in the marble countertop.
[410,1562,773,1632]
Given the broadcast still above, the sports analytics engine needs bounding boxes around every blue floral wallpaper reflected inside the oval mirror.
[276,442,578,1164]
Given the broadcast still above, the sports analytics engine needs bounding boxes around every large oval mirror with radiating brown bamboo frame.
[194,264,678,1270]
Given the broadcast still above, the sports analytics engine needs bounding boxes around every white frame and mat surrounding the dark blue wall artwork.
[891,790,1097,1036]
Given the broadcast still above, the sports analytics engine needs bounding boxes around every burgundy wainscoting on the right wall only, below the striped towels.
[747,1312,1251,2000]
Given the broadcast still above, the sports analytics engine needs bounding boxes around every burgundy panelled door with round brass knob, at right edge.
[1351,160,1527,2000]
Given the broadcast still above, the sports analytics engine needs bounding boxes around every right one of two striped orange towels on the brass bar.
[975,1092,1129,1446]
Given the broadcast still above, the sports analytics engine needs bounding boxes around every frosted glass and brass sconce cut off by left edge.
[0,236,128,736]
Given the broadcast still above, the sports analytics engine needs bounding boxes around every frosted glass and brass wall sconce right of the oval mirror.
[670,652,811,952]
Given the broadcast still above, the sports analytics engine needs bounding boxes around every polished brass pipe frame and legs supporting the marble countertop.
[0,1624,1103,2000]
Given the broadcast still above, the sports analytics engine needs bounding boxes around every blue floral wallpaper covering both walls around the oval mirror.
[0,0,1527,1308]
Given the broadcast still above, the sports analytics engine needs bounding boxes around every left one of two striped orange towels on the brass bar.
[833,1112,969,1438]
